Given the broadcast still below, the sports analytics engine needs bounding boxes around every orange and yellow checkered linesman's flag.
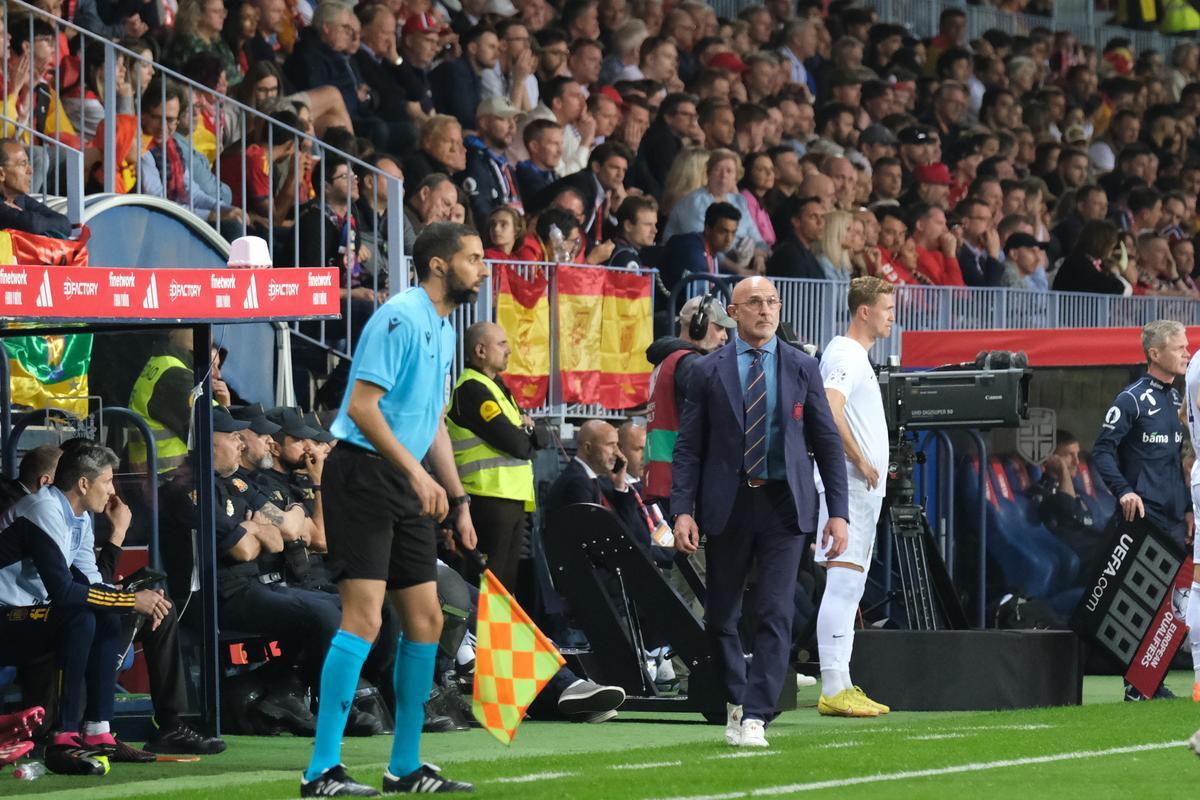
[470,570,566,745]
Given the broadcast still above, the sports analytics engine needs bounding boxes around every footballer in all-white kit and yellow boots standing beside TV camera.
[816,277,895,717]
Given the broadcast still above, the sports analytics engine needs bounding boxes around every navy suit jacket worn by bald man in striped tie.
[671,341,850,536]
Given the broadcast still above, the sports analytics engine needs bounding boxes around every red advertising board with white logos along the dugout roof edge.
[0,266,341,321]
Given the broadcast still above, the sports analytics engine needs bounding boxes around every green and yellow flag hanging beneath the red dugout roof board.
[4,333,92,416]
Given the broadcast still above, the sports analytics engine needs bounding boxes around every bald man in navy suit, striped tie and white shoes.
[671,277,848,747]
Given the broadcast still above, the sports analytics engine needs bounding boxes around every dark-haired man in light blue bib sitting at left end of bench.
[0,441,172,775]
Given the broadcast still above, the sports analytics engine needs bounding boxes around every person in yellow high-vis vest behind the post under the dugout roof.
[130,327,196,475]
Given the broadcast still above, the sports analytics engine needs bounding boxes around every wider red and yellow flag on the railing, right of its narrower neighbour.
[558,266,654,409]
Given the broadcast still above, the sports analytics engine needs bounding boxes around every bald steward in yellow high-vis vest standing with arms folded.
[446,323,547,588]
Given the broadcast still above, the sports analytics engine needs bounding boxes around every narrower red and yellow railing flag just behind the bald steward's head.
[493,264,550,408]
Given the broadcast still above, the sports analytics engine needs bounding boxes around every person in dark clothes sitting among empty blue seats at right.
[1032,428,1104,566]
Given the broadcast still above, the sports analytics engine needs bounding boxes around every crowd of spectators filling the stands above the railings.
[7,0,1200,302]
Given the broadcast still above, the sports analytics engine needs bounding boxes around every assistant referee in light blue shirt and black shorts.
[300,223,487,796]
